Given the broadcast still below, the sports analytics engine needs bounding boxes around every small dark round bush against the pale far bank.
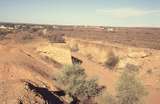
[105,51,119,69]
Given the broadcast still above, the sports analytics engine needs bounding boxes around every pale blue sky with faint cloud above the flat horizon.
[0,0,160,27]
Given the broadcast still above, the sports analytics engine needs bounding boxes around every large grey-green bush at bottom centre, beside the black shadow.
[56,65,102,102]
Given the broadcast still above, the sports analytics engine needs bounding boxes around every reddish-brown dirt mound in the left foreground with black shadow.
[0,43,63,104]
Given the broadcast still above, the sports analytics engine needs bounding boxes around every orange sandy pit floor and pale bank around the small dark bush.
[67,38,160,104]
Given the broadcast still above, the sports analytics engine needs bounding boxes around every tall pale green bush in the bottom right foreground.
[117,64,146,104]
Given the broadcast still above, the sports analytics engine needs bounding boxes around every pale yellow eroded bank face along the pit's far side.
[66,38,159,63]
